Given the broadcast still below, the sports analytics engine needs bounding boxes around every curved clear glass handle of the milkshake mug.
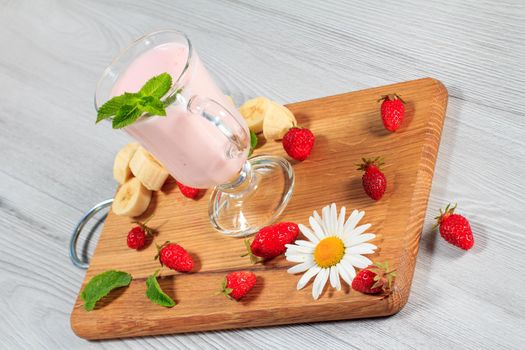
[187,95,249,158]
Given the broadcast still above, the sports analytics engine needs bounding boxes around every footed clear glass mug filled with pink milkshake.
[95,30,294,237]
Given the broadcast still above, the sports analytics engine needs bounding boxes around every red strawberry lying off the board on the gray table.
[435,204,474,250]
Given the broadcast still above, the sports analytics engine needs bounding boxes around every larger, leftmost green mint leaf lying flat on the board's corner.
[80,270,131,311]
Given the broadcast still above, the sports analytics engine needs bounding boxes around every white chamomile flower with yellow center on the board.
[285,203,377,299]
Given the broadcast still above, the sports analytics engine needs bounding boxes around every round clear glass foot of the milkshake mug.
[209,155,294,237]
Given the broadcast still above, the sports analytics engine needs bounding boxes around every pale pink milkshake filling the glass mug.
[111,42,248,188]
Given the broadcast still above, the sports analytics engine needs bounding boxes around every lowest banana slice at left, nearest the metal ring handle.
[111,177,151,216]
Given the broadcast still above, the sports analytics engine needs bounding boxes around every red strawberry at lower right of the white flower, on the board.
[352,262,396,294]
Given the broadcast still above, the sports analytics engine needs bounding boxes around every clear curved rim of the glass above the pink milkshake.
[94,29,193,111]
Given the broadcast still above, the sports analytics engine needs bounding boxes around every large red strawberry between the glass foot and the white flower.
[243,222,299,264]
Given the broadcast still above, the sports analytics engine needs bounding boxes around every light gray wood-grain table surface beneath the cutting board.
[0,0,525,349]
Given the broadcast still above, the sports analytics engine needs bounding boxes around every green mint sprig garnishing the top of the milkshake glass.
[96,73,181,129]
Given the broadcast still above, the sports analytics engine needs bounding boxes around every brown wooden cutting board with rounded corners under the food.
[71,78,448,339]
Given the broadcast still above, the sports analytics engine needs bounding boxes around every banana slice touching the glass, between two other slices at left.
[129,147,169,191]
